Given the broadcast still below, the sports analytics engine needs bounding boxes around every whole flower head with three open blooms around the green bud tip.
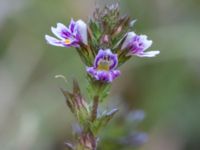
[45,5,159,83]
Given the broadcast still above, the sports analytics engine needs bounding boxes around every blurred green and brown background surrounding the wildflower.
[0,0,200,150]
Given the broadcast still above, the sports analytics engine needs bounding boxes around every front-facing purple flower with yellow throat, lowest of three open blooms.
[87,49,120,83]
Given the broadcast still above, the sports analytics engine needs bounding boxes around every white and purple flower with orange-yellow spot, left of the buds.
[45,19,87,47]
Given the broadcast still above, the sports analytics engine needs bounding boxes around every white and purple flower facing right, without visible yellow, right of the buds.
[121,32,160,57]
